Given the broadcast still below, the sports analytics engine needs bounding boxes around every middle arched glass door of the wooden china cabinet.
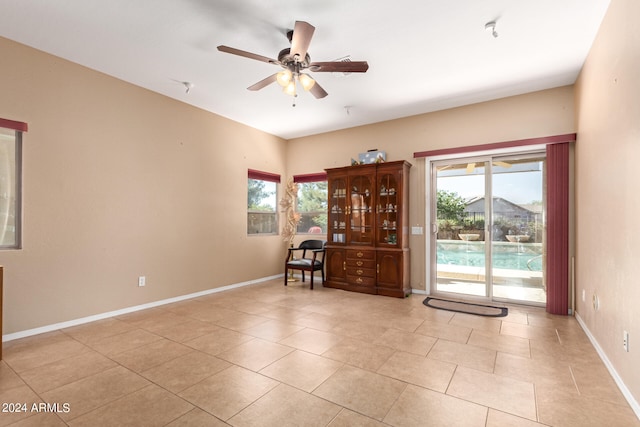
[348,175,374,245]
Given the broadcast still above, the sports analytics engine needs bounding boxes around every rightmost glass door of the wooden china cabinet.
[376,174,401,247]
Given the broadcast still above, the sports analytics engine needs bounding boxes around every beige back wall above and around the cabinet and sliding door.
[287,86,576,290]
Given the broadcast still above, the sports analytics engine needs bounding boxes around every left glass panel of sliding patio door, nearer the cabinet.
[435,162,488,296]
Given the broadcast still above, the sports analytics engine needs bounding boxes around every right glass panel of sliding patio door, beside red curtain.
[491,158,547,303]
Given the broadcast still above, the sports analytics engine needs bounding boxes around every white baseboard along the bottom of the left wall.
[2,274,283,342]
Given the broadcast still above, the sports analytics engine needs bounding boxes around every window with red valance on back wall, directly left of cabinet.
[293,173,327,235]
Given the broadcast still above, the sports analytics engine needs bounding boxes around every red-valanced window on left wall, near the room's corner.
[247,169,280,234]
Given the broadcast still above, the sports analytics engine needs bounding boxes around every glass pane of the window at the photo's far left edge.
[0,128,20,248]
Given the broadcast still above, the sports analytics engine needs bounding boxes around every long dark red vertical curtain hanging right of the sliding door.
[547,142,569,315]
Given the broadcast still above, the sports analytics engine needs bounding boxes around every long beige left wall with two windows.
[0,38,286,334]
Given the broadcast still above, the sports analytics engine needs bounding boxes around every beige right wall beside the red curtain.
[575,0,640,402]
